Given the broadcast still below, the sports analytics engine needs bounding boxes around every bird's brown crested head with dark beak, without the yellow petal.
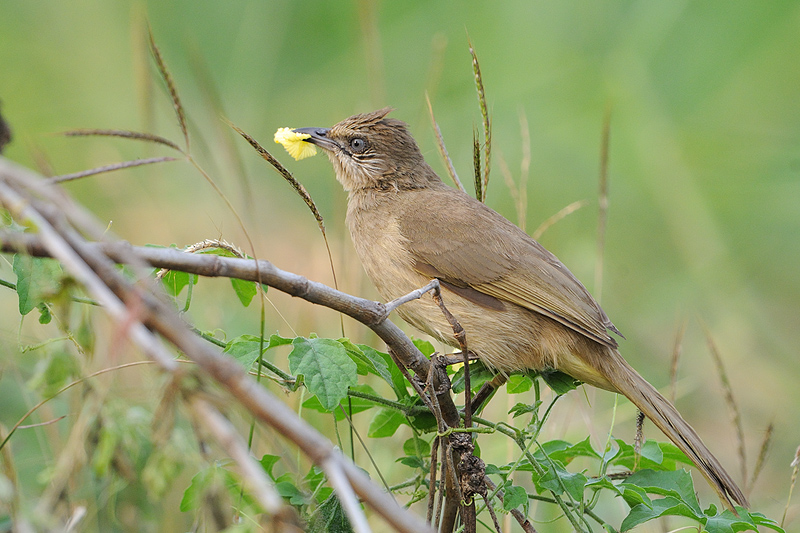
[294,107,439,193]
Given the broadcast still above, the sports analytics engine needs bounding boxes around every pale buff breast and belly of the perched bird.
[348,208,613,390]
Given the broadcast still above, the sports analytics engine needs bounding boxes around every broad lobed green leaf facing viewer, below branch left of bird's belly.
[289,337,358,411]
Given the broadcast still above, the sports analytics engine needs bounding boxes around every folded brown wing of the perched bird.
[398,188,619,347]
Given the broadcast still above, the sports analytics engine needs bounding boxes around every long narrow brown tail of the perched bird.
[597,349,749,510]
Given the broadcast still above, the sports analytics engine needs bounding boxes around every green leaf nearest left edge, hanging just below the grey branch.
[12,254,64,316]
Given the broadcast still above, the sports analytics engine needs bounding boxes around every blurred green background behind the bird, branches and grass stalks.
[0,0,800,529]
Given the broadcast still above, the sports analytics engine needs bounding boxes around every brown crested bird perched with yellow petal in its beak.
[295,108,748,509]
